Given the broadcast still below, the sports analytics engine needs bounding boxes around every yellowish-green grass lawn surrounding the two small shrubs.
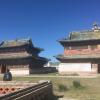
[0,77,100,100]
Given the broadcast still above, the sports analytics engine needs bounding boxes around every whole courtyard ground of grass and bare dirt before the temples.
[0,75,100,100]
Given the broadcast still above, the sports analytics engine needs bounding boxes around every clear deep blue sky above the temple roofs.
[0,0,100,61]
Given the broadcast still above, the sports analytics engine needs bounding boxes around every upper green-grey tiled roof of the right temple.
[59,24,100,42]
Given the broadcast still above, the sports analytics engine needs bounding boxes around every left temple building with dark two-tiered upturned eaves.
[0,39,48,75]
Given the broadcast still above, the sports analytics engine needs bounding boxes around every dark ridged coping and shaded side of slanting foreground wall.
[0,81,53,100]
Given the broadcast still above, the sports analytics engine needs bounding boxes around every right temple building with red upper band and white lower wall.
[56,24,100,75]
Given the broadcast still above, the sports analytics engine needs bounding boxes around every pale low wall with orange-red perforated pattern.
[0,81,37,96]
